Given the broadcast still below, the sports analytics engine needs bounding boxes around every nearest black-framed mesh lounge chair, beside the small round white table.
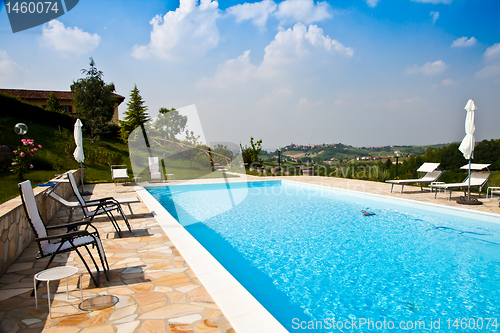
[19,180,109,287]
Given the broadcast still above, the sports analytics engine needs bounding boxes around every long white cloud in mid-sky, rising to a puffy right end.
[198,23,354,88]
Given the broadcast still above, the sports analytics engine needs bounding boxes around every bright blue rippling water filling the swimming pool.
[148,181,500,332]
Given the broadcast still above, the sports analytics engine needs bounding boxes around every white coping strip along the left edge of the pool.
[135,179,288,333]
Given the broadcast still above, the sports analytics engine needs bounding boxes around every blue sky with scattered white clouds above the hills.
[0,0,500,148]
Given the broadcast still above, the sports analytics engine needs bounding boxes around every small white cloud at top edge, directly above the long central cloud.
[275,0,332,24]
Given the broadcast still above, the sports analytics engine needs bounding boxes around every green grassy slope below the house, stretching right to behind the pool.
[0,94,236,203]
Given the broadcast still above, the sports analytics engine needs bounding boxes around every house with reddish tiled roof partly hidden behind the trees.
[0,89,125,125]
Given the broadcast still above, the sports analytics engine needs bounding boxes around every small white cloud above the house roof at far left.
[39,20,101,55]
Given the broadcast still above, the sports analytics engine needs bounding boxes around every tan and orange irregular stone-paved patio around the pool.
[0,176,500,333]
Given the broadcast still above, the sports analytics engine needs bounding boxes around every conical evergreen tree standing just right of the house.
[118,85,150,143]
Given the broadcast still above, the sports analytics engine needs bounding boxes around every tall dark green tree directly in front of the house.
[71,57,117,141]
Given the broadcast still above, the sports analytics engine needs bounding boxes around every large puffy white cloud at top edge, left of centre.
[132,0,220,60]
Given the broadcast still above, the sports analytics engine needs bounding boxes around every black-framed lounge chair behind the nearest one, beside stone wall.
[68,172,132,237]
